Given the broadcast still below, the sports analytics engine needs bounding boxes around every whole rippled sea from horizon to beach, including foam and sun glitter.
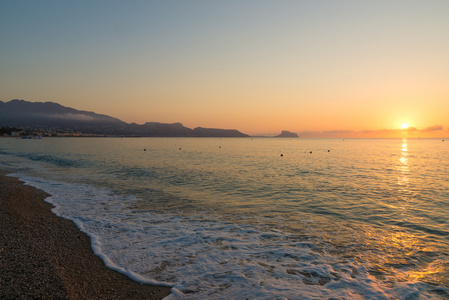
[0,138,449,299]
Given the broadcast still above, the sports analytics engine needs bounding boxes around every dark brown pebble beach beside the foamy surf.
[0,169,170,299]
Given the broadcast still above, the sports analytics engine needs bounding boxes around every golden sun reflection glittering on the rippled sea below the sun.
[332,139,449,286]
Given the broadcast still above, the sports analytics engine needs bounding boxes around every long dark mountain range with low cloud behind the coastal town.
[0,100,248,137]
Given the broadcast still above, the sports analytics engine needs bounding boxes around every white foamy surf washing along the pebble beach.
[8,173,440,299]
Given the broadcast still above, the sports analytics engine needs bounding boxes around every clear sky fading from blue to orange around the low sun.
[0,0,449,137]
